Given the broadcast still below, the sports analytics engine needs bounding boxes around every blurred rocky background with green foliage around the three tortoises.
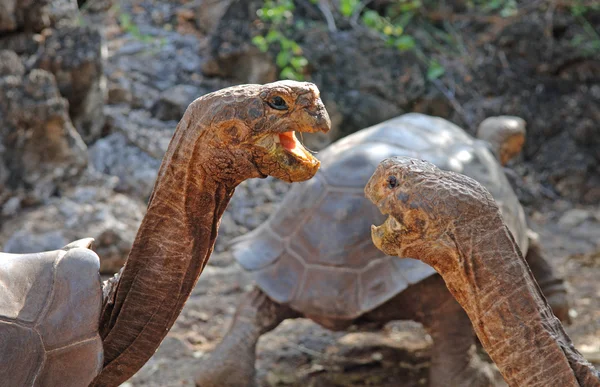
[0,0,600,386]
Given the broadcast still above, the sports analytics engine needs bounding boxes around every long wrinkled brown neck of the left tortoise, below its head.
[92,107,241,386]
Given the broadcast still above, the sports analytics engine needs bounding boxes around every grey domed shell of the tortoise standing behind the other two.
[232,113,528,321]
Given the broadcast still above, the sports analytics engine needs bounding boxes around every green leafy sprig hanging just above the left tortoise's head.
[252,0,308,81]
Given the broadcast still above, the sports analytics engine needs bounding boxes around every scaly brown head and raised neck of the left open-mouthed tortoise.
[91,81,330,386]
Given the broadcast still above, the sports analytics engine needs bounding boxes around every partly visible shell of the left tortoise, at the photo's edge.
[0,240,103,387]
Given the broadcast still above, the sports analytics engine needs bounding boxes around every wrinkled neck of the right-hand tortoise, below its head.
[432,214,600,387]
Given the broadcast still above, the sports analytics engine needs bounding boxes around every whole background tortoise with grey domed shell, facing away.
[196,113,568,387]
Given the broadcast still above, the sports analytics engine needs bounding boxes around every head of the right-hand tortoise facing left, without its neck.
[365,157,499,263]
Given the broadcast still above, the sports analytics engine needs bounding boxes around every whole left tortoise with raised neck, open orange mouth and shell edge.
[0,81,330,387]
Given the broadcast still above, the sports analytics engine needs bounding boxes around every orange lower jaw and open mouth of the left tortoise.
[257,132,321,183]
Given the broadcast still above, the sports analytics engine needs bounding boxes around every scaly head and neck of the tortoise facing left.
[365,157,600,387]
